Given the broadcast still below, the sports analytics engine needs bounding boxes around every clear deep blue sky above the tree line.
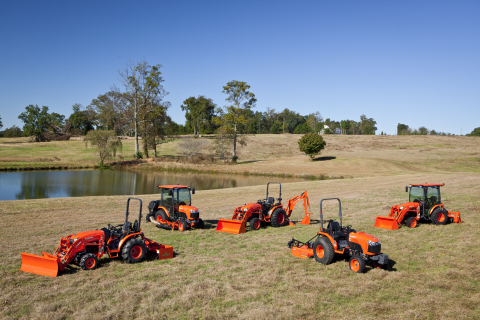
[0,0,480,134]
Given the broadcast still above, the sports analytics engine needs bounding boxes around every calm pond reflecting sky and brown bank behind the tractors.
[0,170,305,200]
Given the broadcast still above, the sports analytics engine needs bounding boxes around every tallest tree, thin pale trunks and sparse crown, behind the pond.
[118,60,168,154]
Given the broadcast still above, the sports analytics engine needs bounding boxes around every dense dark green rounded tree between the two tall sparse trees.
[181,96,216,136]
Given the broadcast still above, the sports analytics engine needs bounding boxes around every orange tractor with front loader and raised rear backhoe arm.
[217,182,310,234]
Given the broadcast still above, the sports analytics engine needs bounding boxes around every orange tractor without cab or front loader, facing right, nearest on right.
[288,198,388,273]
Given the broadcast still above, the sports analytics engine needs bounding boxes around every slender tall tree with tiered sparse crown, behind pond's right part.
[214,80,257,162]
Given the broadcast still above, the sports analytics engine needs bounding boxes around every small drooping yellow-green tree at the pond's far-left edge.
[84,130,122,166]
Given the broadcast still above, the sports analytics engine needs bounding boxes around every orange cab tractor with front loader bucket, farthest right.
[375,183,462,230]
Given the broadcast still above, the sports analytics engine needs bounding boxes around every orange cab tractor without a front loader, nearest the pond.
[147,185,203,231]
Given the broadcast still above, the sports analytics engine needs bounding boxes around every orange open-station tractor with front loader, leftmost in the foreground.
[20,198,173,277]
